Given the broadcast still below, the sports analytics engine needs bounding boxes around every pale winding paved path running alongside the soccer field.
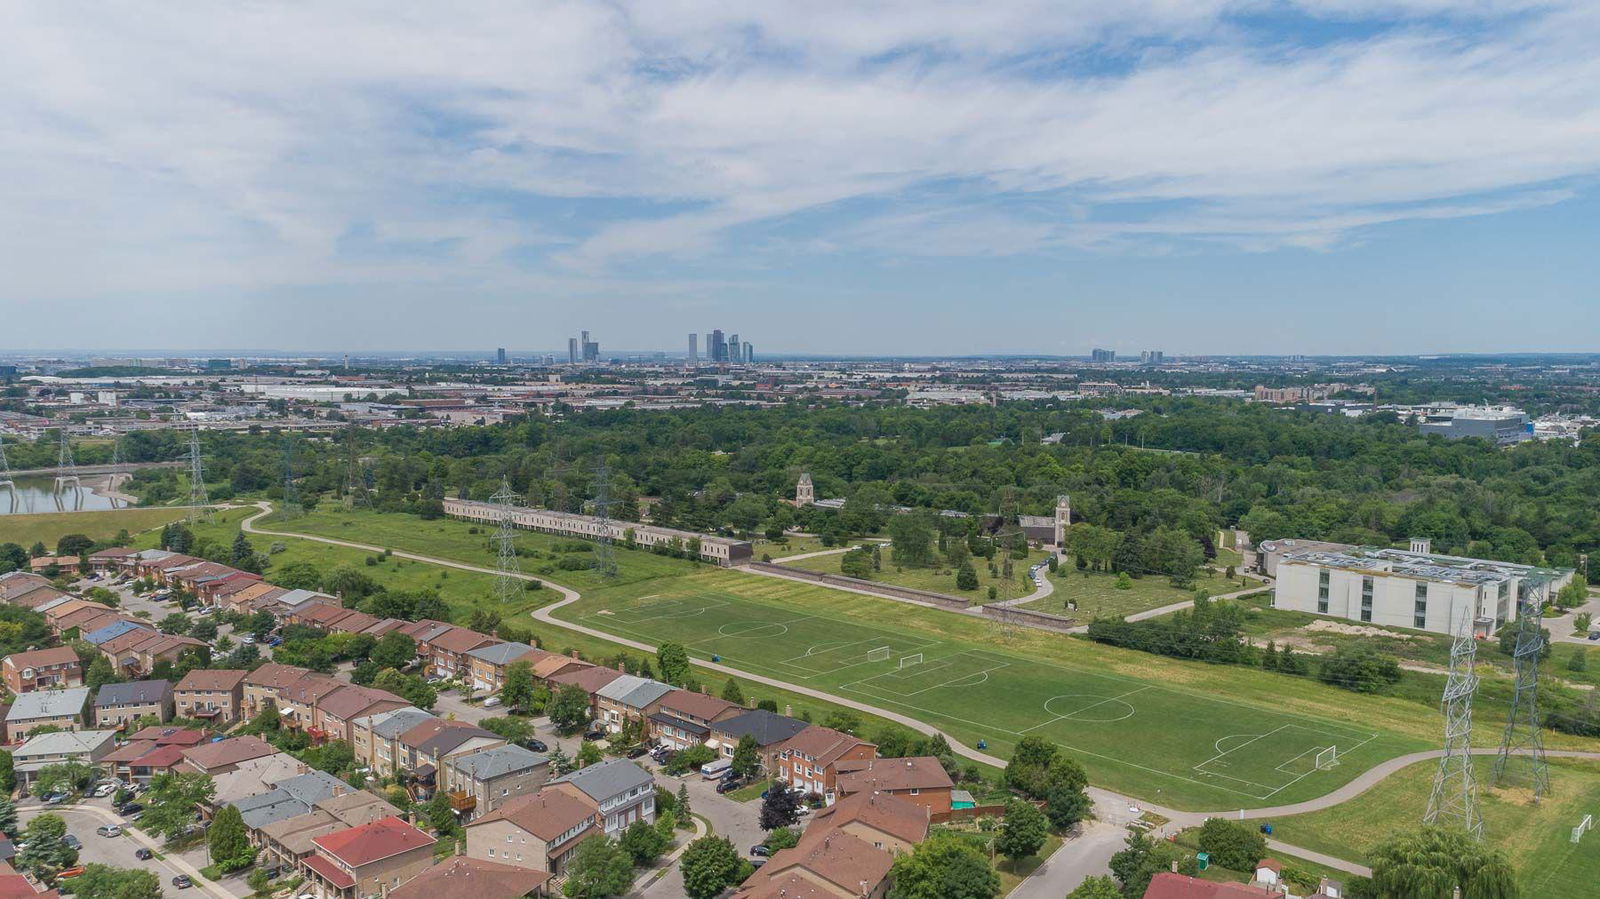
[240,502,1580,873]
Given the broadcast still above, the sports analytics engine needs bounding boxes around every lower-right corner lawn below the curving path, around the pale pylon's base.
[1272,757,1600,899]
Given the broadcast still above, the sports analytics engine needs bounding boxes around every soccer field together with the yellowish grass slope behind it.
[557,569,1437,809]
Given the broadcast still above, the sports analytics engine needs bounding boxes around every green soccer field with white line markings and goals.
[573,585,1394,808]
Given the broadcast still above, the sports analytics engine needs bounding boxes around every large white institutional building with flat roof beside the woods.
[1272,539,1573,637]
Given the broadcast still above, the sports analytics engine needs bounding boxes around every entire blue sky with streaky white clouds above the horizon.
[0,0,1600,355]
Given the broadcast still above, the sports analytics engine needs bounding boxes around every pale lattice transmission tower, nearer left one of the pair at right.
[1422,605,1483,840]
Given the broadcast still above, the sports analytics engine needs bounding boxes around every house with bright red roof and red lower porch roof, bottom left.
[302,816,434,899]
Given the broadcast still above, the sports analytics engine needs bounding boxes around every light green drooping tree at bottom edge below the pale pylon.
[1370,827,1518,899]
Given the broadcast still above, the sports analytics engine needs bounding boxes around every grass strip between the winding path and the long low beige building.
[259,509,698,590]
